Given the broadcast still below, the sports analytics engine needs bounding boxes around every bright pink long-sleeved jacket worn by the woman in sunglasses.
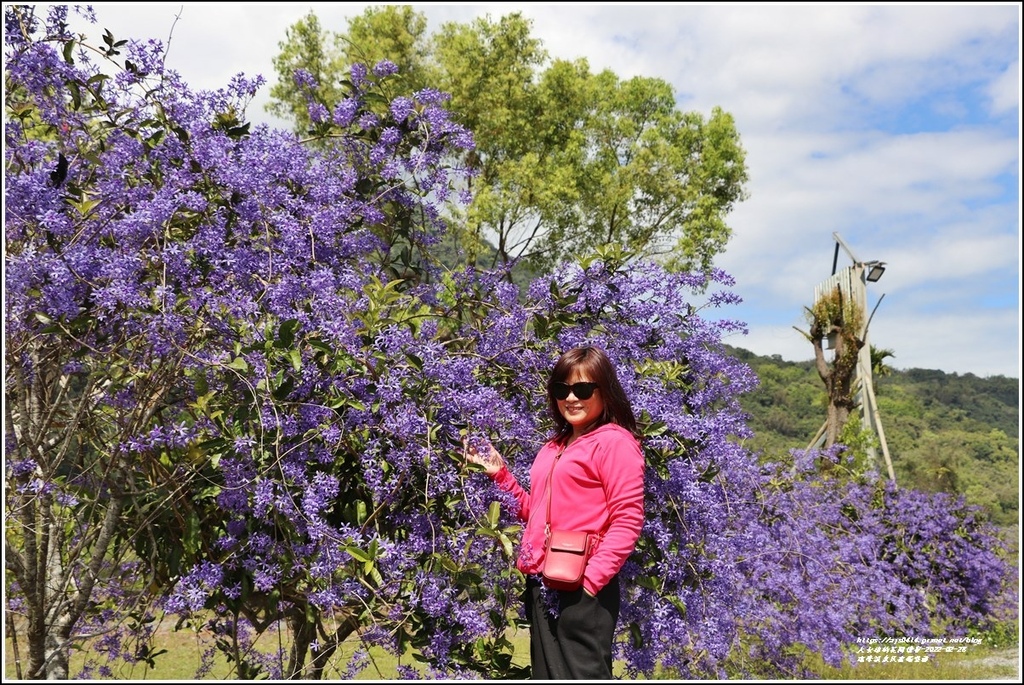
[493,424,644,595]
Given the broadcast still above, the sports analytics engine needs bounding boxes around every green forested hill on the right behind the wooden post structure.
[729,348,1020,525]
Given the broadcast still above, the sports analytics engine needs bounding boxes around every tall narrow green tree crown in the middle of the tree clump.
[432,14,561,272]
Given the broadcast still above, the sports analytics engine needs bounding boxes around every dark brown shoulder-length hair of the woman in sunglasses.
[548,345,640,444]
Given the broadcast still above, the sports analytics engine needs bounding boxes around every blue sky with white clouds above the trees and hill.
[44,2,1021,379]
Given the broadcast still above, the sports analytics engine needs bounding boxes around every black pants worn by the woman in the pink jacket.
[523,575,622,680]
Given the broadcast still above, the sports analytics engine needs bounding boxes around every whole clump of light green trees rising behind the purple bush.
[270,6,746,282]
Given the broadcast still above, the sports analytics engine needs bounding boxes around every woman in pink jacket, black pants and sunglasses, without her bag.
[466,347,644,680]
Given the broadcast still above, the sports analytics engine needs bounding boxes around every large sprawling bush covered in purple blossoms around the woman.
[5,6,1016,679]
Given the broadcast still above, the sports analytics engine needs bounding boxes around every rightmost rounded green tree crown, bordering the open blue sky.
[561,71,746,271]
